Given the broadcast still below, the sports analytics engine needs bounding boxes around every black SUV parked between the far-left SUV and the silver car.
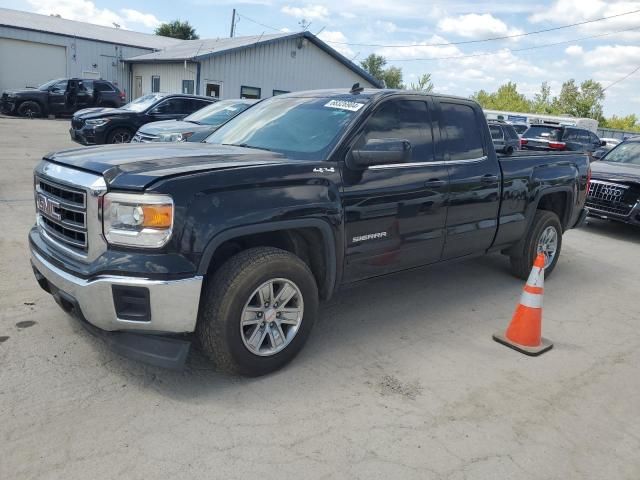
[69,93,217,145]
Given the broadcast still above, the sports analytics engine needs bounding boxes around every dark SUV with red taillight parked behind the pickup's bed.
[521,125,606,154]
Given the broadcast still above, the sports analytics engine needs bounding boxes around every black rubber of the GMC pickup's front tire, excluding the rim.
[196,247,318,376]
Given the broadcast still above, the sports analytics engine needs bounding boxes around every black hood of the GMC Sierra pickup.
[44,142,292,190]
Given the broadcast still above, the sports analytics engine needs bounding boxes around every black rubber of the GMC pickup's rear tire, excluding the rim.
[510,210,562,280]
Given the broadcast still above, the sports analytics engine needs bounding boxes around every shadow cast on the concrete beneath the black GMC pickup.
[84,248,601,402]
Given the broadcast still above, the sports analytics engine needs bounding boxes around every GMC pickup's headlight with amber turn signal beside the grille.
[102,192,174,248]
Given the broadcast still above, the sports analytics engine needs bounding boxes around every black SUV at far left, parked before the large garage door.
[0,78,125,117]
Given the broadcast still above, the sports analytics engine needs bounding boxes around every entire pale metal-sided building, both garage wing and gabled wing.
[0,8,381,99]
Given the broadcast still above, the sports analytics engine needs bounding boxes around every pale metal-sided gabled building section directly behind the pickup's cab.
[125,32,382,99]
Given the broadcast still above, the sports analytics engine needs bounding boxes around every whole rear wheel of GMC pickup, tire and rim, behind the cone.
[510,210,562,280]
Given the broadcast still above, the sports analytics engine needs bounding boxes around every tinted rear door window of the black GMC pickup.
[440,102,484,160]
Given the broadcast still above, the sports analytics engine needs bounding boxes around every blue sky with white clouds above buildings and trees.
[0,0,640,116]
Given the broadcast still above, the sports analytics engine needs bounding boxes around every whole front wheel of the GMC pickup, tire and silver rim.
[196,247,318,376]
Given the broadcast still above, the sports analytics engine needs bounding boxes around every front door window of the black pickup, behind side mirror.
[357,100,434,162]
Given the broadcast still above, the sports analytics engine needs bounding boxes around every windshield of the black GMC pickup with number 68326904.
[206,96,367,160]
